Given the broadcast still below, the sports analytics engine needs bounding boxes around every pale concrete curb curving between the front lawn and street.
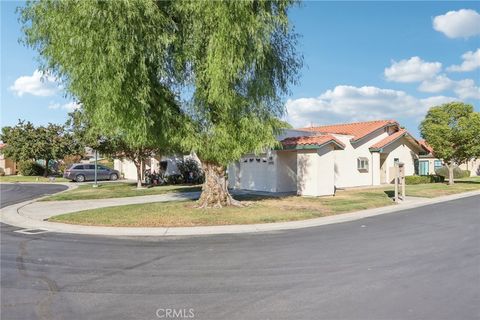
[0,190,480,236]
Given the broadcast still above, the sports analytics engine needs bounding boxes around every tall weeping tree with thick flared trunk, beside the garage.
[174,0,302,208]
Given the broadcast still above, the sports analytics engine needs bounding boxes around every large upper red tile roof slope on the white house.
[301,120,399,141]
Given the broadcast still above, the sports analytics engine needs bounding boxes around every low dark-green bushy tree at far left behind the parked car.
[0,121,83,176]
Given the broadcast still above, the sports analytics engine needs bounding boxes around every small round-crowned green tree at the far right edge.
[420,102,480,185]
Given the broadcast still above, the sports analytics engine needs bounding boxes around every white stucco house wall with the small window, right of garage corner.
[334,129,388,188]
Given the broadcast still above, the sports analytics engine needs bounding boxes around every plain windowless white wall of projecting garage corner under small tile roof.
[297,145,335,196]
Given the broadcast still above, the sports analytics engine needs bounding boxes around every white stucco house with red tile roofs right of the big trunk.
[228,120,425,196]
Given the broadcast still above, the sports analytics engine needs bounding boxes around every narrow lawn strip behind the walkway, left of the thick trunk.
[42,182,201,201]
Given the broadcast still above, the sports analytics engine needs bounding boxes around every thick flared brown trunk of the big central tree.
[197,162,243,208]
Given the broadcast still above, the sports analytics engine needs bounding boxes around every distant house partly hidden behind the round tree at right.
[417,139,480,177]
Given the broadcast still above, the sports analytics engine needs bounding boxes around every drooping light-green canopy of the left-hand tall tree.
[20,0,186,185]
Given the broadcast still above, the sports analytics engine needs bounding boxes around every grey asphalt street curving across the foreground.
[0,184,480,320]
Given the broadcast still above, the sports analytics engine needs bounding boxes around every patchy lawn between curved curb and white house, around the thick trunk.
[49,178,480,227]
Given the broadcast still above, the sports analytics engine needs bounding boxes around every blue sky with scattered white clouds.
[1,1,480,135]
